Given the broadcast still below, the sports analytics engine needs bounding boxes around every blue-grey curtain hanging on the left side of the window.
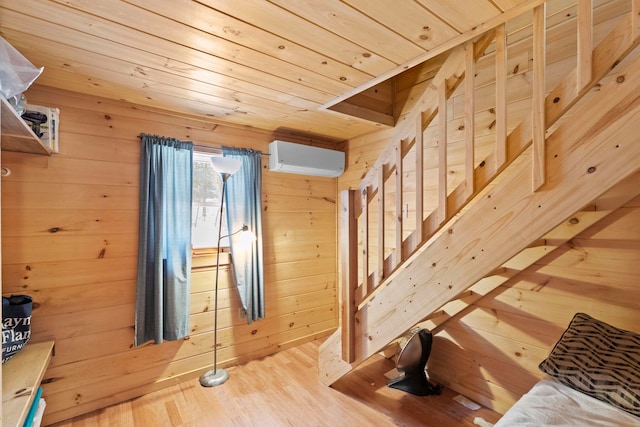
[135,134,193,346]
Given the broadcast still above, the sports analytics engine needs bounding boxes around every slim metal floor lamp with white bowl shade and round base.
[200,156,241,387]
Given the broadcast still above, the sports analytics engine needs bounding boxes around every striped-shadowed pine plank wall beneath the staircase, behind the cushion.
[427,198,640,413]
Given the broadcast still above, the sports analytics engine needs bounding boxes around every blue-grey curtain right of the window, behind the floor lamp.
[222,147,265,323]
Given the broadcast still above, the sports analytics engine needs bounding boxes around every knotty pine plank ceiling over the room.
[0,0,540,139]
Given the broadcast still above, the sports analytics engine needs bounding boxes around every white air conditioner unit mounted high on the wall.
[269,140,344,178]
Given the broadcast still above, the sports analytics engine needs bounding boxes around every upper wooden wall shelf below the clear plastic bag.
[0,96,51,156]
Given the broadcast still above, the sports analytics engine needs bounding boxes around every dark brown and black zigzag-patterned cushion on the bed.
[539,313,640,417]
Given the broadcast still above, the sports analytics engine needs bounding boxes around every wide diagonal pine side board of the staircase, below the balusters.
[320,48,640,384]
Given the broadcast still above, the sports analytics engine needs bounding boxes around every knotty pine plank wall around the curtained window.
[2,86,337,424]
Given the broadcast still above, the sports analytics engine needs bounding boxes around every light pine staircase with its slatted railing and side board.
[320,0,640,384]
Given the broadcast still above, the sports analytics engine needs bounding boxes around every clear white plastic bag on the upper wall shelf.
[0,37,44,99]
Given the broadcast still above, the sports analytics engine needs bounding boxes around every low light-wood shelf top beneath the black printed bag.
[2,341,54,426]
